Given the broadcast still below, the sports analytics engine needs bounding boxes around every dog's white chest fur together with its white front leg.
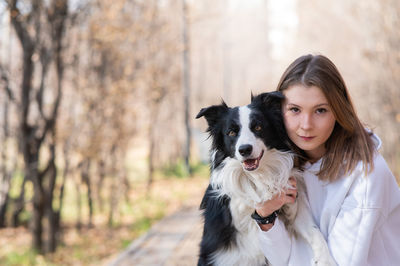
[211,150,336,266]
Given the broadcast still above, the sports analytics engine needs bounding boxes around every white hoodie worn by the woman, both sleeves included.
[259,136,400,266]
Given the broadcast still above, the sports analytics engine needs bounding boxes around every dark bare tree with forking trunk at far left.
[7,0,68,252]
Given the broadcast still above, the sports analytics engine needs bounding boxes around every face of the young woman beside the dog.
[282,85,336,161]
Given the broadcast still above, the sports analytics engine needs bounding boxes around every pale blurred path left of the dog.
[109,207,203,266]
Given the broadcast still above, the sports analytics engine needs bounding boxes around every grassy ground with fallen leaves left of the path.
[0,164,208,266]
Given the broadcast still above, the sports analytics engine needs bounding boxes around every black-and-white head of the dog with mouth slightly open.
[196,92,288,171]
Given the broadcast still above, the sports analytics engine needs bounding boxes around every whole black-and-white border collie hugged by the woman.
[196,92,335,265]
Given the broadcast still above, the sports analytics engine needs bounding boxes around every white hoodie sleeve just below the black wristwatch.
[258,219,292,266]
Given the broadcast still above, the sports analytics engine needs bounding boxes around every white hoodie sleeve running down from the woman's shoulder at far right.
[328,155,399,266]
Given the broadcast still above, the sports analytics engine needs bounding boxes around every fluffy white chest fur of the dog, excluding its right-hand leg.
[211,150,293,265]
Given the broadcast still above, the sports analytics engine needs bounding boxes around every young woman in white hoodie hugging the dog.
[256,55,400,266]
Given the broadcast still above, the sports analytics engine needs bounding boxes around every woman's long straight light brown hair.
[277,55,375,181]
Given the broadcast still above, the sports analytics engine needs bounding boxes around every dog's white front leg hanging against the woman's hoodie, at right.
[293,193,336,266]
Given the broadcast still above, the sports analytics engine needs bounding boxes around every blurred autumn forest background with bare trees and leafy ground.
[0,0,400,265]
